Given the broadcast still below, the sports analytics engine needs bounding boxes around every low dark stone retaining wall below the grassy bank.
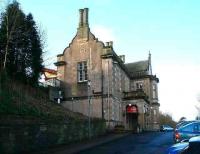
[0,119,105,153]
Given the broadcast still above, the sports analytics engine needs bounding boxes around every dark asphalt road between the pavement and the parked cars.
[79,132,173,154]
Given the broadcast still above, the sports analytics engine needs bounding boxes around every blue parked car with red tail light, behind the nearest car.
[174,121,200,143]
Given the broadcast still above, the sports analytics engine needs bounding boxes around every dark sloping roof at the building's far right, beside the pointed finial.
[125,60,149,73]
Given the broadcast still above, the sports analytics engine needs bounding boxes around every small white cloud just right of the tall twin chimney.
[91,25,117,42]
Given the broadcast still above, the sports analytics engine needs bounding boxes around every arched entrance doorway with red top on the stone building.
[126,104,138,131]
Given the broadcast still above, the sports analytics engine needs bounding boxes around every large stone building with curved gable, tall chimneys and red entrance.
[55,8,159,130]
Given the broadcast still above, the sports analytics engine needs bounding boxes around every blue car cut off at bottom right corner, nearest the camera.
[167,136,200,154]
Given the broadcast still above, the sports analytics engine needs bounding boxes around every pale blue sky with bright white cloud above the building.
[0,0,200,121]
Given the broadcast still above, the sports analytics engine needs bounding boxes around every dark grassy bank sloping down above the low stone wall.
[0,74,86,120]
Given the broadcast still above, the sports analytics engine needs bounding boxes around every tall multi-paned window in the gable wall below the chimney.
[77,61,88,82]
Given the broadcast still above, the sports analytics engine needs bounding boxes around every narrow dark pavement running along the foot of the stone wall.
[37,133,130,154]
